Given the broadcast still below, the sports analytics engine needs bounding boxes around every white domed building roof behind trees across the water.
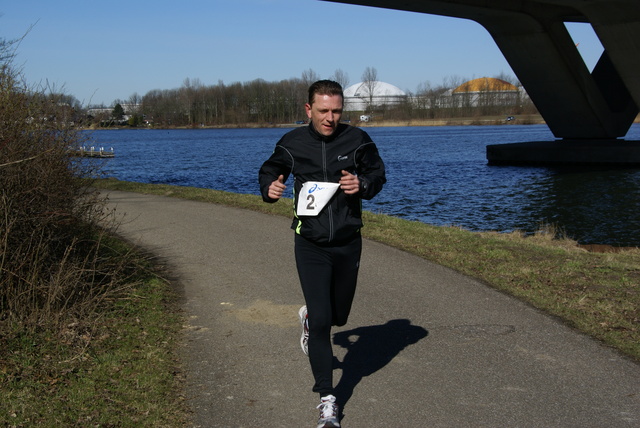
[344,81,407,111]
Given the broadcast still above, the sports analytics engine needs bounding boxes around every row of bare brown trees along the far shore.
[84,67,536,127]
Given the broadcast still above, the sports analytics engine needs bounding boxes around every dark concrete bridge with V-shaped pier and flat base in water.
[328,0,640,164]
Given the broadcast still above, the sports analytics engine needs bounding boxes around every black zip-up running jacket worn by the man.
[258,124,387,244]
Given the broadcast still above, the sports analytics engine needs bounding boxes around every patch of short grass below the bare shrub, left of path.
[0,239,188,427]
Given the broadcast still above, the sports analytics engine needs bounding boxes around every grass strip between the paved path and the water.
[98,180,640,361]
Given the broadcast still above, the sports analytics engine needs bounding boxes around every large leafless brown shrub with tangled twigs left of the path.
[0,35,138,335]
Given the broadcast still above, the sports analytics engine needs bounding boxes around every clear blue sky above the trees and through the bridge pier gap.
[0,0,602,106]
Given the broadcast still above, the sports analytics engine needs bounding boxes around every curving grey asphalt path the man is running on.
[109,191,640,428]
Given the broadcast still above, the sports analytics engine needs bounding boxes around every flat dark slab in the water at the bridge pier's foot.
[487,140,640,167]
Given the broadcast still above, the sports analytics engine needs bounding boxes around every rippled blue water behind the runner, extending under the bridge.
[91,125,640,246]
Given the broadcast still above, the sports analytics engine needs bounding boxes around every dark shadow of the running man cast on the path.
[333,319,429,411]
